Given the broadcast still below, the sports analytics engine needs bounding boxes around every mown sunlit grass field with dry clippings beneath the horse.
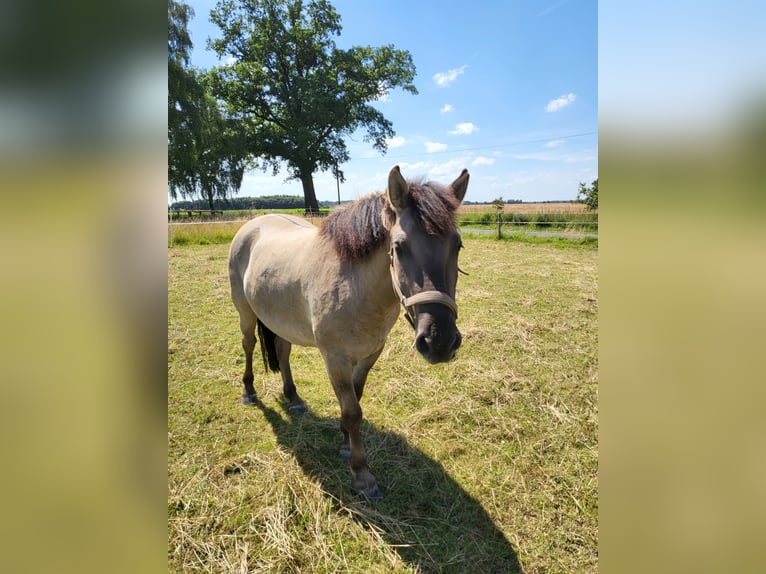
[168,237,598,574]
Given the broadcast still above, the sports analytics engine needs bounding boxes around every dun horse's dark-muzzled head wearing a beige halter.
[386,166,468,363]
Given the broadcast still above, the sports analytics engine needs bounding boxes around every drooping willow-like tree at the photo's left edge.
[168,0,247,210]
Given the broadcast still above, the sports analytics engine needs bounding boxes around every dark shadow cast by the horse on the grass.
[255,400,523,573]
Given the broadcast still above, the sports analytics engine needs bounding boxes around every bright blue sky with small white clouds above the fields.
[182,0,598,202]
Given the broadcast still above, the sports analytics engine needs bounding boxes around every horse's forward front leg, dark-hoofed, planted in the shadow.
[323,353,383,500]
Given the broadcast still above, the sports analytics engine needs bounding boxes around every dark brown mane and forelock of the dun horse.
[319,181,460,260]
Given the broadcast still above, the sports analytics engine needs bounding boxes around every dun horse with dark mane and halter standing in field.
[229,166,469,500]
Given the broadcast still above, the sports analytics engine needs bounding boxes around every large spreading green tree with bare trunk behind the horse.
[209,0,417,211]
